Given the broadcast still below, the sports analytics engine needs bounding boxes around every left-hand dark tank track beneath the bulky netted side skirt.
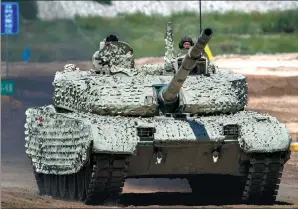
[34,155,128,205]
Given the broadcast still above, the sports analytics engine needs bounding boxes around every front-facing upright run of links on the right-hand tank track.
[242,152,290,204]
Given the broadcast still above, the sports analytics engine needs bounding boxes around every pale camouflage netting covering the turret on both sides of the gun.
[53,65,247,116]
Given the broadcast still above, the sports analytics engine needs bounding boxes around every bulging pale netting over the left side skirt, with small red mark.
[25,106,93,174]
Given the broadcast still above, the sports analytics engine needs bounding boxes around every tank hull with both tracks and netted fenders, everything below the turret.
[25,106,291,204]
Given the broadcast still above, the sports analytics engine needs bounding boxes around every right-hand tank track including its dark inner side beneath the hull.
[188,152,290,204]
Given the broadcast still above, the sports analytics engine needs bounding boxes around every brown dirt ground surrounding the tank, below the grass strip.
[1,54,298,208]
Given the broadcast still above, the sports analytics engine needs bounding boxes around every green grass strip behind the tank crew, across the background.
[1,9,298,62]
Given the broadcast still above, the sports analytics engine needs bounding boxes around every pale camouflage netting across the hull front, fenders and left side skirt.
[25,106,290,174]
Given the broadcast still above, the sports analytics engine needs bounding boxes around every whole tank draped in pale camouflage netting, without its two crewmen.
[25,23,291,204]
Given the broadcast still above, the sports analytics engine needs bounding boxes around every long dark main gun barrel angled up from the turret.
[161,28,213,103]
